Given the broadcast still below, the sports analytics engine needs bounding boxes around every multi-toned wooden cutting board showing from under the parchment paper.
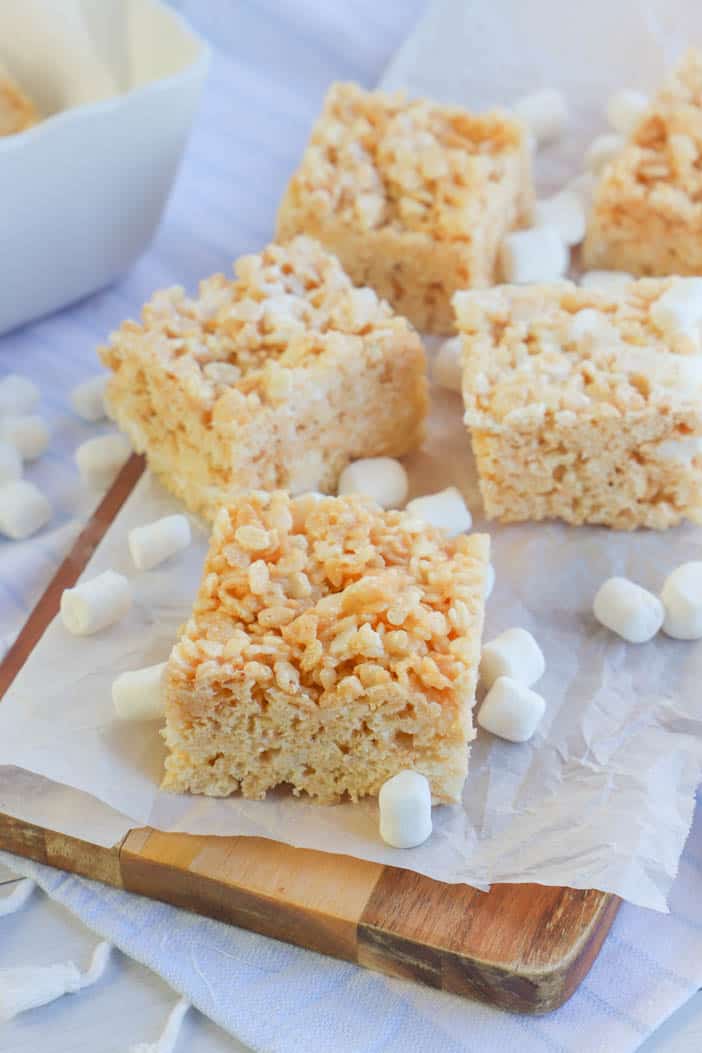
[0,457,619,1013]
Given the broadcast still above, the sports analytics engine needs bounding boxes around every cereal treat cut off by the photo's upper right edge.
[584,51,702,275]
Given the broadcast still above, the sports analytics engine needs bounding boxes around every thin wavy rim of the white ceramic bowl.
[0,0,213,155]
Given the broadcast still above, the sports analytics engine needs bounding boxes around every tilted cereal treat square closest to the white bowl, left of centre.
[100,237,427,518]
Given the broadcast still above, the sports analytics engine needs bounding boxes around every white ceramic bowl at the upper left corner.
[0,0,209,333]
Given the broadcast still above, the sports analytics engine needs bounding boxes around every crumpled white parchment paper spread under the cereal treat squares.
[0,0,702,910]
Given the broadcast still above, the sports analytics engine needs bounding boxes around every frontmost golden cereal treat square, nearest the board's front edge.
[163,491,489,802]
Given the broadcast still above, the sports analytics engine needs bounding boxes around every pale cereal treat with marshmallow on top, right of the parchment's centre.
[454,278,702,530]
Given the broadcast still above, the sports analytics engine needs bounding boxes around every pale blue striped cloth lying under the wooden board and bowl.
[0,0,702,1053]
